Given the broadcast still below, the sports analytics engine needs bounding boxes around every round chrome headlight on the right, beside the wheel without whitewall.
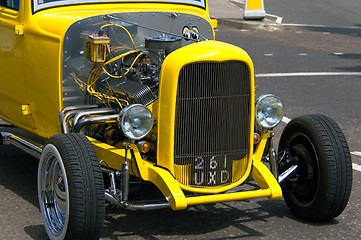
[256,94,283,128]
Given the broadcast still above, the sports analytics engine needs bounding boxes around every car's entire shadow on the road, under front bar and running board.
[0,143,338,240]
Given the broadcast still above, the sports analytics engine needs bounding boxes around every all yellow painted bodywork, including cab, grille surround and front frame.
[0,1,281,204]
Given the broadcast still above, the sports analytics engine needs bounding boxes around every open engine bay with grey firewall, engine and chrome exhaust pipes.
[61,12,213,154]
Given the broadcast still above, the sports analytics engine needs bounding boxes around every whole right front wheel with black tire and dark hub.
[279,115,352,221]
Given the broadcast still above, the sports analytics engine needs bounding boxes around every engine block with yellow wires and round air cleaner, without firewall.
[86,31,182,105]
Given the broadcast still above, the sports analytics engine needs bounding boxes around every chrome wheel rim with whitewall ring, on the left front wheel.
[38,144,69,239]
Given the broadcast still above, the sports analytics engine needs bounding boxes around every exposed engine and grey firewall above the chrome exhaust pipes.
[62,12,213,108]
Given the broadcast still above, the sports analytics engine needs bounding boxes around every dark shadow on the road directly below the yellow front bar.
[102,200,290,239]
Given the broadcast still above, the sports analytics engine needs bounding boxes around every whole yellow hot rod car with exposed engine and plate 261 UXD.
[0,0,352,239]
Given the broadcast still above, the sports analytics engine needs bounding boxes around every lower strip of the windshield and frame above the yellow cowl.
[32,0,206,13]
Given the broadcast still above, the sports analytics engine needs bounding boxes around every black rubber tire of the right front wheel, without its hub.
[279,115,352,221]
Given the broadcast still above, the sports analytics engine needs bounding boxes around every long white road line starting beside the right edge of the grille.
[256,72,361,78]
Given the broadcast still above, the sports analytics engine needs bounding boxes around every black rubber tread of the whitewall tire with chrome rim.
[38,134,104,239]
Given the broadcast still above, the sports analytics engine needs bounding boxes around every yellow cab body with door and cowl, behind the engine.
[0,1,214,138]
